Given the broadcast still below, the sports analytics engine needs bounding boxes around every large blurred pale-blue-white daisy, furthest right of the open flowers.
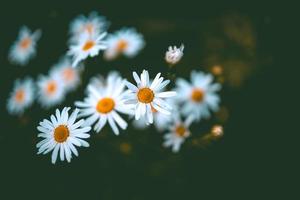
[176,71,221,120]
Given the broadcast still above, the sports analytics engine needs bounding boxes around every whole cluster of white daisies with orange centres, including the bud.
[7,12,223,163]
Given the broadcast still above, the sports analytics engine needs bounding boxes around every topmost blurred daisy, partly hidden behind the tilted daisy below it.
[70,12,109,41]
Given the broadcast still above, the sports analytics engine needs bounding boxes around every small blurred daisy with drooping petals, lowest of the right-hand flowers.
[163,113,194,153]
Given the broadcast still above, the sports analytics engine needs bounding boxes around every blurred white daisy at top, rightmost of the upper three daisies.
[104,28,145,60]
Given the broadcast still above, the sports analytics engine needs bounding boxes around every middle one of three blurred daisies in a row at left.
[37,74,66,108]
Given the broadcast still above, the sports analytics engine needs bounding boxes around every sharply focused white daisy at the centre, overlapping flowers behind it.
[126,70,176,124]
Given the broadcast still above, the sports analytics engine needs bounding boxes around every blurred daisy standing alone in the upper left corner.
[8,26,42,66]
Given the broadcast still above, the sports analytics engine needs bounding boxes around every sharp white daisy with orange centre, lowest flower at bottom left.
[36,107,91,164]
